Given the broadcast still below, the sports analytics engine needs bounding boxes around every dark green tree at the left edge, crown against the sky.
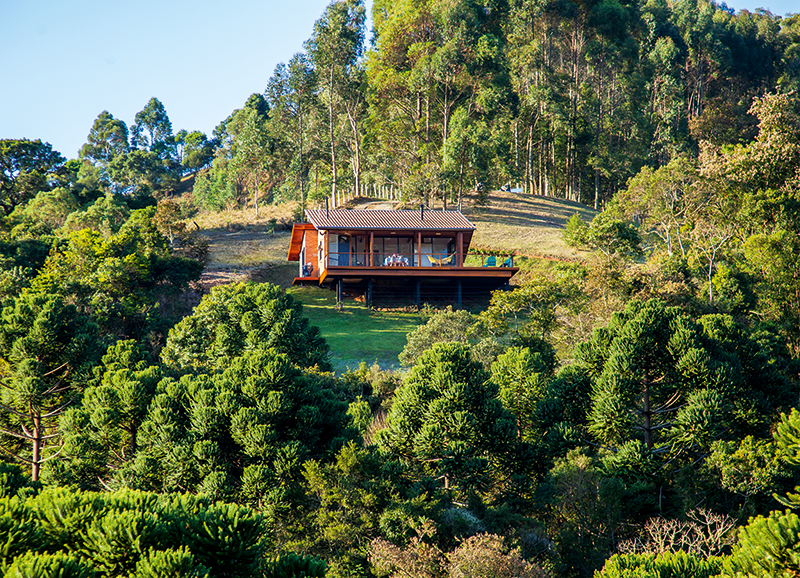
[0,139,65,215]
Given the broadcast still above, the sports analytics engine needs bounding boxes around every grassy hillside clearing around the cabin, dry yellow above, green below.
[188,191,594,371]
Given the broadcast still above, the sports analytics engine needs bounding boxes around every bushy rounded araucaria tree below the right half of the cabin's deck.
[377,343,516,492]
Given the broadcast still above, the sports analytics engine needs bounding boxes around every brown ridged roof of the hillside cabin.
[306,209,475,231]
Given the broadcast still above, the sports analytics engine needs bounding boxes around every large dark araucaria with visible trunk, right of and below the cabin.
[576,301,729,450]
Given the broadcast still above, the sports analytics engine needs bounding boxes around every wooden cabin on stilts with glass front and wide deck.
[289,209,519,306]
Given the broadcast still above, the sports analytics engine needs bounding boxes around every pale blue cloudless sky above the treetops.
[0,0,800,158]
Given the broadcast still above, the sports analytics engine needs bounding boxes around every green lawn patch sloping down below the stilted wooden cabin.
[287,287,420,372]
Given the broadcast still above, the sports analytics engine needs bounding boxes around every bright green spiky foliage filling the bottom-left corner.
[0,489,266,577]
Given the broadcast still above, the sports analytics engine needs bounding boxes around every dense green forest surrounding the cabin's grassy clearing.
[0,0,800,578]
